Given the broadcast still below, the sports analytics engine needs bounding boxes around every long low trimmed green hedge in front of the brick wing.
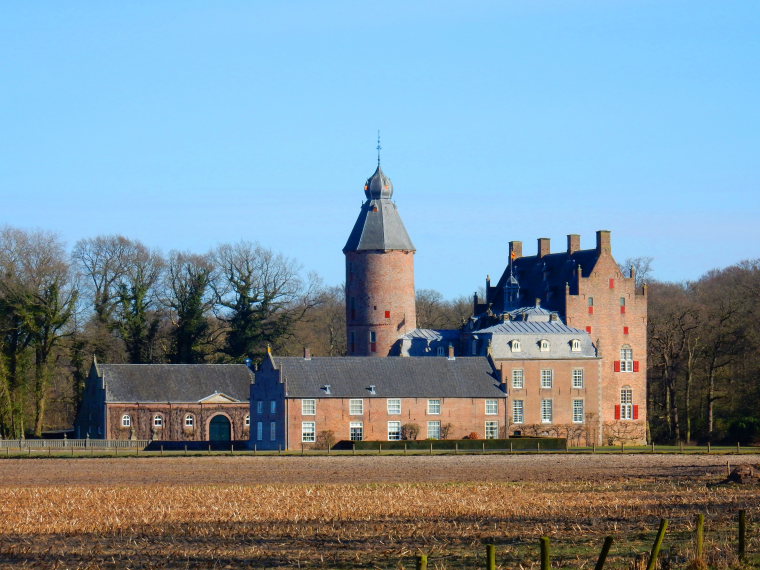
[333,437,567,451]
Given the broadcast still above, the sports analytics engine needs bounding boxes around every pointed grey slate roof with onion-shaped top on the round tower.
[343,166,416,253]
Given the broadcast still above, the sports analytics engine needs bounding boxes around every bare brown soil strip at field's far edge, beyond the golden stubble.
[0,453,760,486]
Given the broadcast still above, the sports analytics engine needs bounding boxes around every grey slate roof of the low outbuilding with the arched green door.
[96,364,253,403]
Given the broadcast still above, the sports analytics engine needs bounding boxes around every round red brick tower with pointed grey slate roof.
[343,162,417,356]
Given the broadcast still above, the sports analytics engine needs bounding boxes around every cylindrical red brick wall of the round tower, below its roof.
[346,251,417,356]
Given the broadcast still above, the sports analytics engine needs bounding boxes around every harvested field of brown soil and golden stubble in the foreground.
[0,454,760,568]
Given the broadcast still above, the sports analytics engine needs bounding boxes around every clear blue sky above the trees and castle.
[0,0,760,297]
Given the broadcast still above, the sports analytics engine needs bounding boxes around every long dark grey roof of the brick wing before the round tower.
[268,356,506,398]
